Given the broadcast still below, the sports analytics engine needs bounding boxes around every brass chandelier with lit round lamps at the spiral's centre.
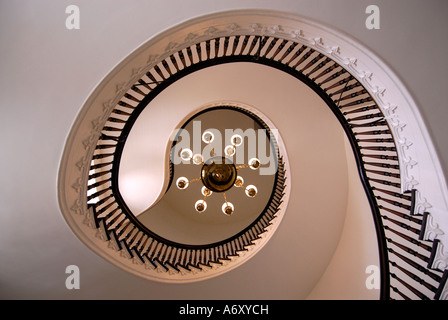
[176,131,260,216]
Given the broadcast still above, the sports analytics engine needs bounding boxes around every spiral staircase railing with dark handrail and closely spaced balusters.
[88,34,447,299]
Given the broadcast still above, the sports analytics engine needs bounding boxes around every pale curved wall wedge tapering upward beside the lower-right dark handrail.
[307,139,380,300]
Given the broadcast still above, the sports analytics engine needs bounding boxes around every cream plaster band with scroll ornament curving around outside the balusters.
[59,10,448,282]
